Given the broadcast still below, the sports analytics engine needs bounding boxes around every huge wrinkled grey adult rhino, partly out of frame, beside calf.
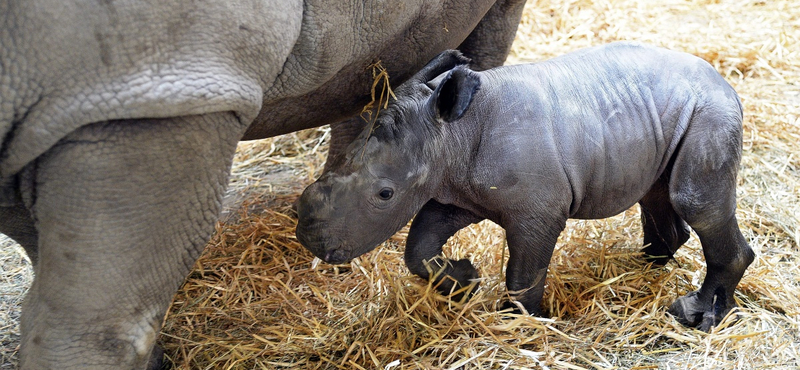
[0,0,524,369]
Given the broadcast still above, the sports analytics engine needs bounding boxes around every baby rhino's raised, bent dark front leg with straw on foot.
[405,200,483,301]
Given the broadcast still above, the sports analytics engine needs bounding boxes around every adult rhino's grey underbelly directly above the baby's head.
[243,0,495,140]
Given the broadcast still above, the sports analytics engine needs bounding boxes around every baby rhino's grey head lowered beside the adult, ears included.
[297,50,480,263]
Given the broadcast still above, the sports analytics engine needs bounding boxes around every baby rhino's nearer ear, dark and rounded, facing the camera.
[431,66,481,122]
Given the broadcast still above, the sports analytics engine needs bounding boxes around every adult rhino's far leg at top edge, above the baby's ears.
[458,0,525,70]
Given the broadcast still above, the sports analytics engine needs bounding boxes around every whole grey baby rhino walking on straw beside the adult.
[297,43,754,331]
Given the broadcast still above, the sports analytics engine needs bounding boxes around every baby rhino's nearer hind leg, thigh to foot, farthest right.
[669,109,754,331]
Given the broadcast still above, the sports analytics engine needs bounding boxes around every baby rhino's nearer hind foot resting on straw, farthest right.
[667,291,737,332]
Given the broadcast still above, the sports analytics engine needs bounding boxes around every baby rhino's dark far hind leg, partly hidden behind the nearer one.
[639,179,689,266]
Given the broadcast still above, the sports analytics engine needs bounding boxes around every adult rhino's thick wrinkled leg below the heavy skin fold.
[20,113,244,369]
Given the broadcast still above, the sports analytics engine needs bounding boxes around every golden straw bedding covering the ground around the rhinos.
[4,0,800,369]
